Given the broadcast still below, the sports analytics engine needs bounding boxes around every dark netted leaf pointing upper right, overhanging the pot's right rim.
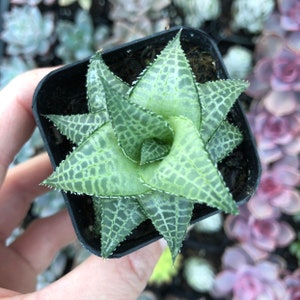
[198,79,248,143]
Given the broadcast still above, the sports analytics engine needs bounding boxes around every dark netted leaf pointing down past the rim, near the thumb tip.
[139,192,194,262]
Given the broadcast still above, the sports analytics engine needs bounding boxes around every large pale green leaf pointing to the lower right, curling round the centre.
[140,117,237,213]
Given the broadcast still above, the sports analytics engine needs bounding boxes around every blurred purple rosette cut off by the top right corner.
[278,0,300,31]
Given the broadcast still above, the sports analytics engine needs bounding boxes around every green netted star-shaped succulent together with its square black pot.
[33,27,260,259]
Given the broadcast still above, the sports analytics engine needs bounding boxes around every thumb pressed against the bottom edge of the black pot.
[31,242,163,300]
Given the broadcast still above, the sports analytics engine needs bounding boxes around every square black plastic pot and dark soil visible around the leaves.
[33,27,261,257]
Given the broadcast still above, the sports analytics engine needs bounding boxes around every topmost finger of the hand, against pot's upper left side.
[0,68,54,185]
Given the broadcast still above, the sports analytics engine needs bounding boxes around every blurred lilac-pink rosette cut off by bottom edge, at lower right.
[211,246,289,300]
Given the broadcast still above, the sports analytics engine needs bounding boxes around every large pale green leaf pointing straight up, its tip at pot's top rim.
[129,32,201,128]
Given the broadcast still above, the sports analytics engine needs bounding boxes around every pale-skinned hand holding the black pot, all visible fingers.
[0,68,162,300]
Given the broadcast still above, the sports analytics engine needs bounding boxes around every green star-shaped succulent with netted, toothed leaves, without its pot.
[44,31,247,260]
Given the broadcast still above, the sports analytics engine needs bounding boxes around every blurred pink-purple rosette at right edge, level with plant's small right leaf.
[248,103,300,164]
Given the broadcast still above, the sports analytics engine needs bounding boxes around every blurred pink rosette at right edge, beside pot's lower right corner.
[247,156,300,219]
